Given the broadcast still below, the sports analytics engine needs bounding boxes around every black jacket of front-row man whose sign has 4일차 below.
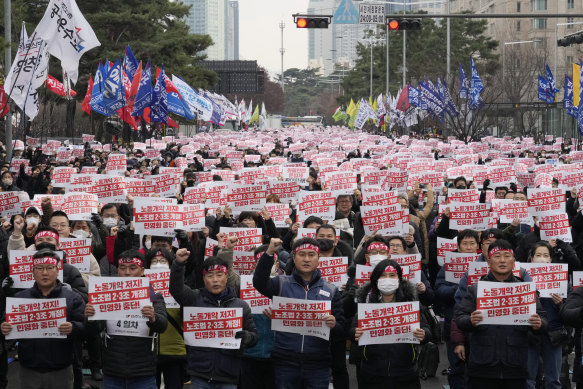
[89,287,168,378]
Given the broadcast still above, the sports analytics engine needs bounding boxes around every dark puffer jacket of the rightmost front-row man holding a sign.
[455,273,547,379]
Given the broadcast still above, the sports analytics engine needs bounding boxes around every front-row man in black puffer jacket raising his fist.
[170,249,257,389]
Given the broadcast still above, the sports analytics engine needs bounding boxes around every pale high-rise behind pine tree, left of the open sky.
[181,0,239,60]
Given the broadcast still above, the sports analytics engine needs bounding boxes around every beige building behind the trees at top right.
[451,0,583,85]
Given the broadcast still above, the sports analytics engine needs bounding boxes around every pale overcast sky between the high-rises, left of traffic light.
[239,0,308,78]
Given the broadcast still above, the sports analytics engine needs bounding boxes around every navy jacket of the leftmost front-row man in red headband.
[14,280,85,373]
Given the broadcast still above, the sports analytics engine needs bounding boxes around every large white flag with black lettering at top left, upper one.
[36,0,101,84]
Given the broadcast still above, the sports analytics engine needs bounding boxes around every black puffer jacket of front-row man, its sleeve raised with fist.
[169,260,258,384]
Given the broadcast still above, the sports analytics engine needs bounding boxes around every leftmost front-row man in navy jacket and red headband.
[1,249,85,389]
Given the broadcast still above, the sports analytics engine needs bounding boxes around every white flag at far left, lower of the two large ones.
[5,23,49,120]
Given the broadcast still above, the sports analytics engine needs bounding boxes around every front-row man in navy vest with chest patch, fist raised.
[253,238,345,389]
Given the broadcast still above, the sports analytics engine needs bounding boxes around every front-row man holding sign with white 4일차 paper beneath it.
[85,250,168,389]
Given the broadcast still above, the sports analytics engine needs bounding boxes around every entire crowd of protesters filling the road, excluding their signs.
[0,128,583,389]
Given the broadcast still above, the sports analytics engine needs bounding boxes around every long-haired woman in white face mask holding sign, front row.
[350,259,431,389]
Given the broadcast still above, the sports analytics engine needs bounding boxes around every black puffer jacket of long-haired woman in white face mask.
[350,281,431,378]
